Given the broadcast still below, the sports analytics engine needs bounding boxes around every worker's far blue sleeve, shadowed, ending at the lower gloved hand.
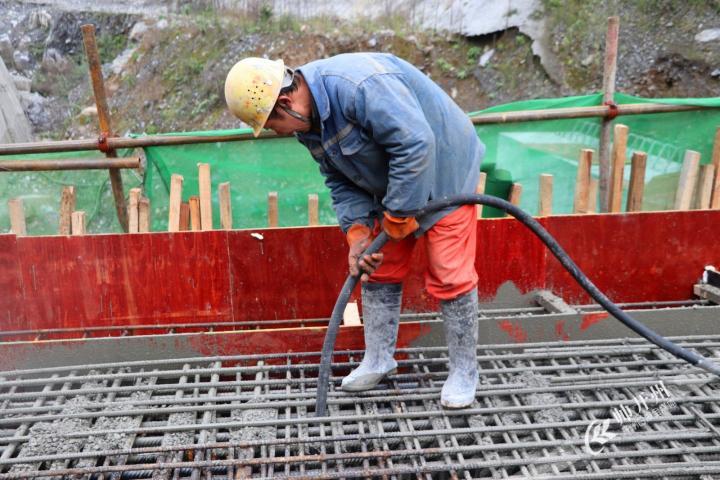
[320,162,373,233]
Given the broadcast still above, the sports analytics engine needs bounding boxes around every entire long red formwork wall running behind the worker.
[0,211,720,331]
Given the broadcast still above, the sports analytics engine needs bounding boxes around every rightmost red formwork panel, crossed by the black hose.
[546,210,720,303]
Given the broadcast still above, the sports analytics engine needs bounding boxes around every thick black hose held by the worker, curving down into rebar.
[315,194,720,417]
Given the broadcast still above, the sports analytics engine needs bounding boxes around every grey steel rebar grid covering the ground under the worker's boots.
[0,336,720,480]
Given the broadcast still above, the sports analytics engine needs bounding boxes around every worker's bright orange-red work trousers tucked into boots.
[369,205,478,300]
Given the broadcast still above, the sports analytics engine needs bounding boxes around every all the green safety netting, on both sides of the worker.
[0,94,720,234]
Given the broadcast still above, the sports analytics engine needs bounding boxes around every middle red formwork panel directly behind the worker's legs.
[228,219,545,321]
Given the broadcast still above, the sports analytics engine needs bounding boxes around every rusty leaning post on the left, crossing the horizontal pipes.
[80,24,128,232]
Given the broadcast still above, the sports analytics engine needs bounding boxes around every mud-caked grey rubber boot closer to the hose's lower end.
[342,283,402,392]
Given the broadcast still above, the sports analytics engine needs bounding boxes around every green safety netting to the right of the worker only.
[471,94,720,215]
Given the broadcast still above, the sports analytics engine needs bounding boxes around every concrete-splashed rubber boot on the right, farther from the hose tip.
[440,288,478,408]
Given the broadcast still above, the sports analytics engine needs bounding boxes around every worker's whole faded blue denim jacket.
[296,53,485,232]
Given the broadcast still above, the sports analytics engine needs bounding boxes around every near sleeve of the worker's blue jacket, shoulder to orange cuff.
[348,73,435,216]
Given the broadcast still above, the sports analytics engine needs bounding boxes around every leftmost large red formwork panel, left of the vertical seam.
[17,231,231,329]
